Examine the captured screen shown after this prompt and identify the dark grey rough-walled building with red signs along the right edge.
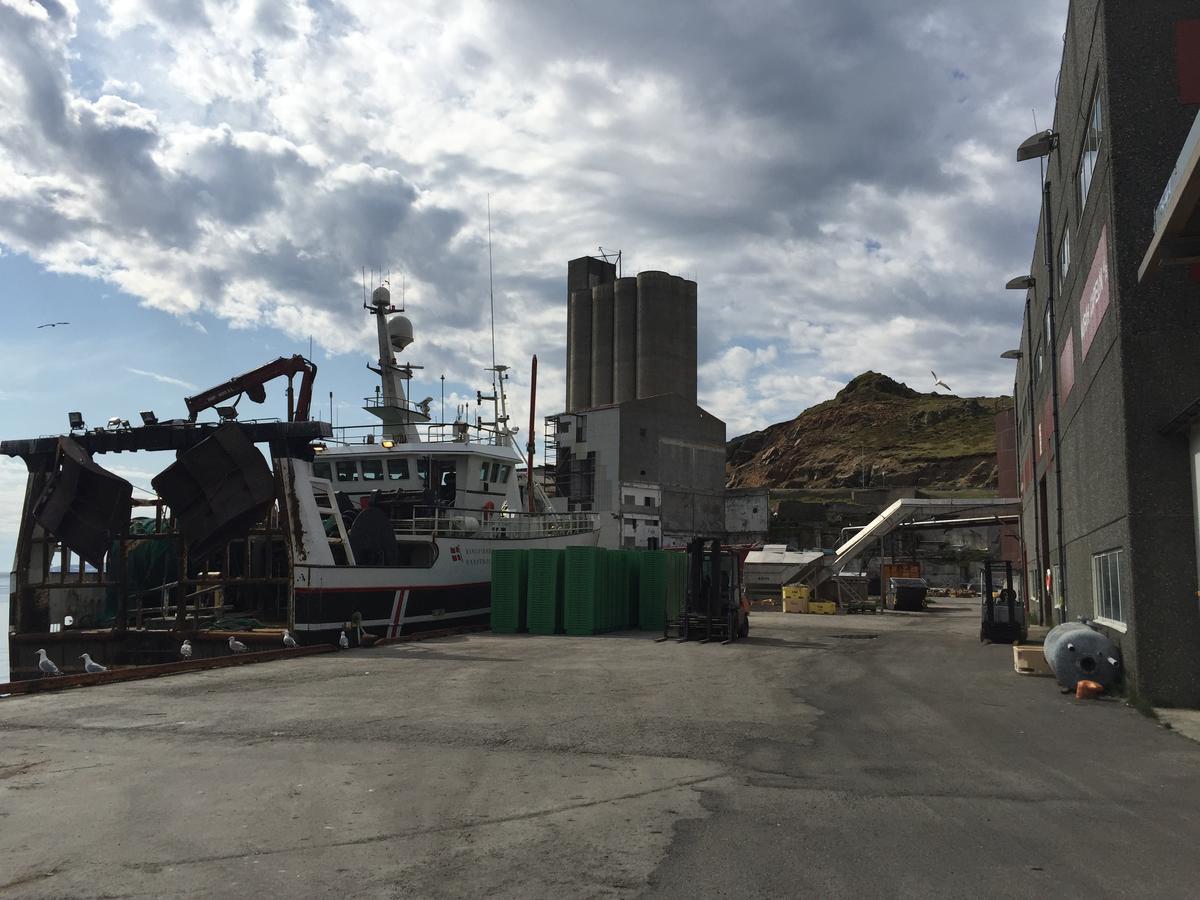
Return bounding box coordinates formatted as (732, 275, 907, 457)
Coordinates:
(1004, 0, 1200, 706)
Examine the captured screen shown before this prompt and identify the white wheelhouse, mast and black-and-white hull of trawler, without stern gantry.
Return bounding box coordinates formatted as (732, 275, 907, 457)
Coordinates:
(275, 286, 599, 640)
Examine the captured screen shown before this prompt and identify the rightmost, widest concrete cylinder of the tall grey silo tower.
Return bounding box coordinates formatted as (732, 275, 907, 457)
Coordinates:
(637, 271, 695, 398)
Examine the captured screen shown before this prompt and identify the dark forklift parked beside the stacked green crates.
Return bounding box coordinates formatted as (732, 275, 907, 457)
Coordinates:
(659, 538, 750, 644)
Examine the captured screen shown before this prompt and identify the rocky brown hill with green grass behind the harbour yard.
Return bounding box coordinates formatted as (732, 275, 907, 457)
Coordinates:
(725, 372, 1013, 490)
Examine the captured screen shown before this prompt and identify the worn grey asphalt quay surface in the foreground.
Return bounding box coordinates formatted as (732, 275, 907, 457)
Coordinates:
(0, 600, 1200, 899)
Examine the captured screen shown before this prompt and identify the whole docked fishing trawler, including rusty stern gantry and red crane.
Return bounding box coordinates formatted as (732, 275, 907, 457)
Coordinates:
(0, 284, 599, 668)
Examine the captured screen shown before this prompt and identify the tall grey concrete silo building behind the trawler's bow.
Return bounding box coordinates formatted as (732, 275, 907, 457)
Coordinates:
(545, 257, 725, 547)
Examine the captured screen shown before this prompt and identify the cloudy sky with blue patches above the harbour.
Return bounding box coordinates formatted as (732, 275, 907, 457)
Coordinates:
(0, 0, 1067, 553)
